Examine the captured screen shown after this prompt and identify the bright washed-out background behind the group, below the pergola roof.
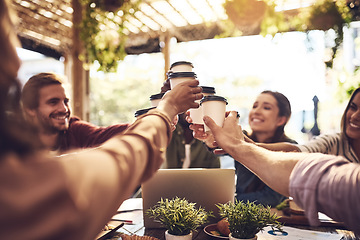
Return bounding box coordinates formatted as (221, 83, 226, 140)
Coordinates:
(12, 0, 360, 166)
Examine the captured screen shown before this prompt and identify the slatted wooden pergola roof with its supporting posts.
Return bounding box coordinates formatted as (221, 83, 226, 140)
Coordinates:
(12, 0, 315, 119)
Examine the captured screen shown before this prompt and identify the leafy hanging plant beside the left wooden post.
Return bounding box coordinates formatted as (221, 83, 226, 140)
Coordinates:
(80, 0, 140, 72)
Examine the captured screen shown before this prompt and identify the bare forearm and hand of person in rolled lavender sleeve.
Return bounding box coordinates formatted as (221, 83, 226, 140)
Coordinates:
(204, 112, 302, 196)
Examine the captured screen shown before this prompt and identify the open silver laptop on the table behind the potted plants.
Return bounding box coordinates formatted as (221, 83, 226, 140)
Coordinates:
(141, 168, 235, 228)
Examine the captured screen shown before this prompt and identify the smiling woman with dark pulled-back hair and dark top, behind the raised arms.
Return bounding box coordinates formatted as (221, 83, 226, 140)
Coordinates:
(235, 90, 296, 207)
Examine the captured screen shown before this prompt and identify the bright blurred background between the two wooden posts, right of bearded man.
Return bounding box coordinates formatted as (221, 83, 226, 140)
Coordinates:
(90, 53, 164, 126)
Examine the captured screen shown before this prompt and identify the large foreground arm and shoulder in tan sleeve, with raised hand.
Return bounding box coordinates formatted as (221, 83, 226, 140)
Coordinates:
(0, 80, 202, 239)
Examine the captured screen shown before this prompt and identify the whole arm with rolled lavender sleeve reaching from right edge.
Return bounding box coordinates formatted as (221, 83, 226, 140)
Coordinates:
(204, 112, 360, 234)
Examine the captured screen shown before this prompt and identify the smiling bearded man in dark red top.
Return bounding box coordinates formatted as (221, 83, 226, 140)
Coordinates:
(21, 73, 129, 153)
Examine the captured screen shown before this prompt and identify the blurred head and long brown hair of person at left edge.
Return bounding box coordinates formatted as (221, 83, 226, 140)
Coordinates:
(0, 0, 40, 156)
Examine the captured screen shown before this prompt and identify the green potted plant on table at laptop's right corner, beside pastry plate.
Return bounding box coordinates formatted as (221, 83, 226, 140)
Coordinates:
(217, 200, 282, 240)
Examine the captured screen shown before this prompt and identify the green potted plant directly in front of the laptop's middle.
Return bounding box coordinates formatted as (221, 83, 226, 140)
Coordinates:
(146, 197, 212, 240)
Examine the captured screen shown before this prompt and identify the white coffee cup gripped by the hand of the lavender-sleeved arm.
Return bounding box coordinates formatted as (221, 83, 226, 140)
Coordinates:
(200, 95, 228, 132)
